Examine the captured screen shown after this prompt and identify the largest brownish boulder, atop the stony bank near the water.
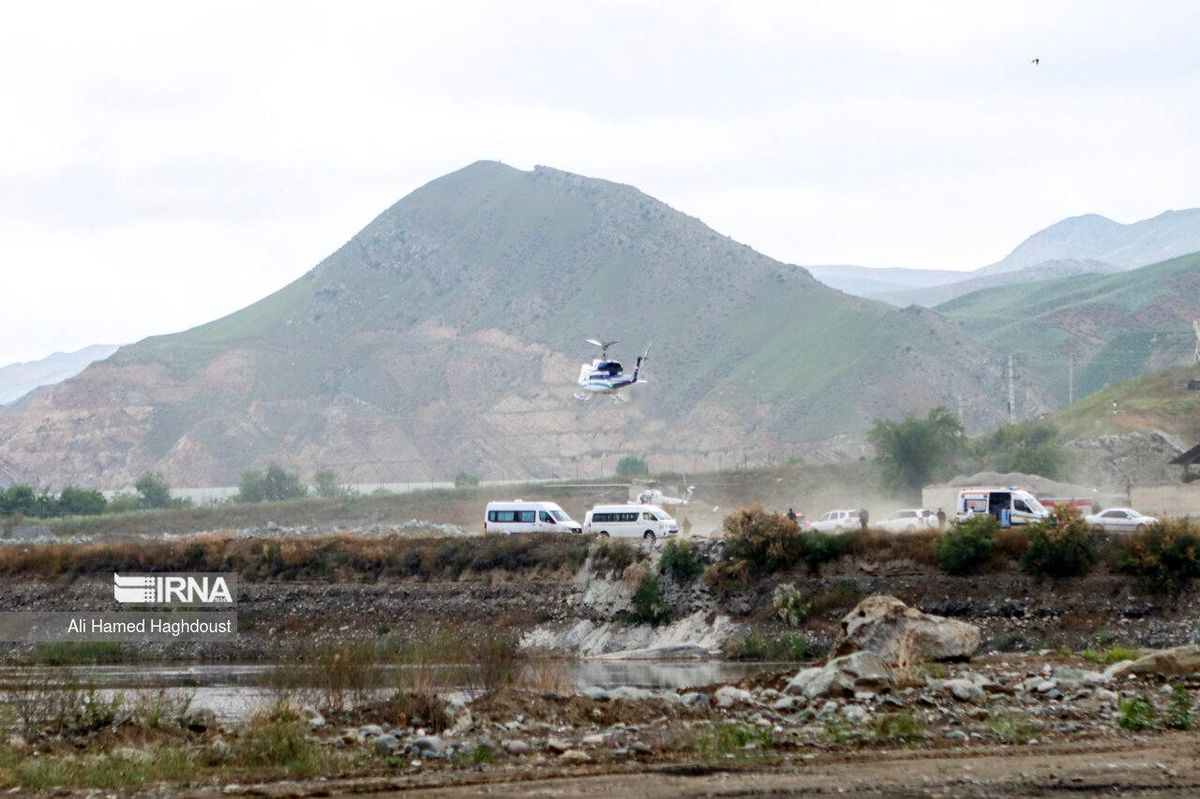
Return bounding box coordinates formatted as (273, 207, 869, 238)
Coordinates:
(836, 596, 980, 663)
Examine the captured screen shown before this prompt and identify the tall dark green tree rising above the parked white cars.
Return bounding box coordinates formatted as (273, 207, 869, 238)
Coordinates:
(866, 408, 962, 494)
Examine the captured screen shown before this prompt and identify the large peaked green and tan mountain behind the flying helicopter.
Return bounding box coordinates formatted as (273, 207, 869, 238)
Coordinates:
(0, 162, 1002, 486)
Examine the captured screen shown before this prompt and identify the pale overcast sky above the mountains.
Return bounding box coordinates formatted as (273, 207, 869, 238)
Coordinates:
(0, 0, 1200, 364)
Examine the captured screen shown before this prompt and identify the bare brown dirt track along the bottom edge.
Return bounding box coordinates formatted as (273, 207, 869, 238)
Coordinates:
(216, 734, 1200, 799)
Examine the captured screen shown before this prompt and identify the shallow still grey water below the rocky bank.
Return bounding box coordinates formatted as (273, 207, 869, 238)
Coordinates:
(0, 660, 787, 721)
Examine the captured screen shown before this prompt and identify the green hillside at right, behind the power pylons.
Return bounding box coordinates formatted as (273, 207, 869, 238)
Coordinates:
(937, 253, 1200, 405)
